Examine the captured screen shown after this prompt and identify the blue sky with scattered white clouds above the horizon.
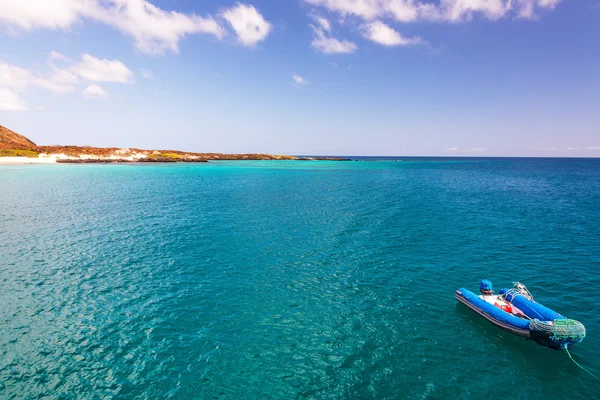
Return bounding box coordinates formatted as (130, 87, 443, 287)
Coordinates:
(0, 0, 600, 157)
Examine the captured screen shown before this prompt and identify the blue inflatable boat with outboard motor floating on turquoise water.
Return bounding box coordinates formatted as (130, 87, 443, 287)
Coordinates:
(456, 280, 585, 349)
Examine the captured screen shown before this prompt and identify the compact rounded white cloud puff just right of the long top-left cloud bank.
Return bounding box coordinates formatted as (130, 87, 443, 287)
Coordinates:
(221, 3, 272, 47)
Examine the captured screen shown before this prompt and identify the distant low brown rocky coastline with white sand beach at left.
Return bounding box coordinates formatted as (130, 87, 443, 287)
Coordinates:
(0, 125, 347, 164)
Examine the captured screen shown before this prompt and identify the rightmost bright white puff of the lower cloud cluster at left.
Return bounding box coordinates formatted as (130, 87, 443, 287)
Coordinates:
(71, 54, 133, 83)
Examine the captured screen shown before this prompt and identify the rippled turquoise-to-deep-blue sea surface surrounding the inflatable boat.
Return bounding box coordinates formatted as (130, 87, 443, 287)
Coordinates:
(0, 158, 600, 399)
